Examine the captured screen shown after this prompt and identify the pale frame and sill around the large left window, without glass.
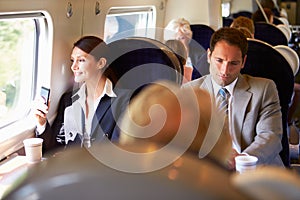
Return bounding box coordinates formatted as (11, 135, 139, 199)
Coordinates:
(0, 11, 53, 160)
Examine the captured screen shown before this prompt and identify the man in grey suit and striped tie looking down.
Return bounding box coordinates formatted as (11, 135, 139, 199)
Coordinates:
(183, 27, 283, 169)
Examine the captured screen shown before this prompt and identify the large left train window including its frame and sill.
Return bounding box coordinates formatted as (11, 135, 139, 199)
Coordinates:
(0, 12, 52, 159)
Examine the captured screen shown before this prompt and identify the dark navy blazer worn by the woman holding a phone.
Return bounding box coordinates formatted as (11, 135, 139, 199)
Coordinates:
(36, 88, 131, 152)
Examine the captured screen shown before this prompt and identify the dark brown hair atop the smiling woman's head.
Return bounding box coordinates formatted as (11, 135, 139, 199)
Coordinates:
(73, 36, 108, 60)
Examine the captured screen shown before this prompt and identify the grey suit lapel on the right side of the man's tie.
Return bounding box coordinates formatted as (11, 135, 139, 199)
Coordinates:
(231, 75, 252, 151)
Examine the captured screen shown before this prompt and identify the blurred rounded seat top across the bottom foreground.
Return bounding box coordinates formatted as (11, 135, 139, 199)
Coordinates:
(5, 143, 249, 200)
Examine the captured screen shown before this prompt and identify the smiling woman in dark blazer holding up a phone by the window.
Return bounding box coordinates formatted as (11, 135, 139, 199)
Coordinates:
(35, 36, 129, 153)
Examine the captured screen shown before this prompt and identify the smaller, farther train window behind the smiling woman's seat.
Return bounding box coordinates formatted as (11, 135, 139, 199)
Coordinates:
(104, 6, 156, 43)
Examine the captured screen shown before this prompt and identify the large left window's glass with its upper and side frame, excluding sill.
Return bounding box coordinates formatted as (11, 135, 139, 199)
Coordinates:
(0, 13, 46, 130)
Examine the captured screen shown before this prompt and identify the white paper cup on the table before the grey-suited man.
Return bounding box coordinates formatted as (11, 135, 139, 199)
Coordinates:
(235, 156, 258, 174)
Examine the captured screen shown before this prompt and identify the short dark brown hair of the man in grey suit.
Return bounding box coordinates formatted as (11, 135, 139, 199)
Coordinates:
(210, 27, 248, 59)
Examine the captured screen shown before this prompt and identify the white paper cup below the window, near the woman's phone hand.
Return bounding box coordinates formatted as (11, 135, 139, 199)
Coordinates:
(23, 138, 43, 163)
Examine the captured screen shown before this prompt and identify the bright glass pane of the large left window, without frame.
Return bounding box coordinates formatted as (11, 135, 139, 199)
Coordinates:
(0, 16, 35, 127)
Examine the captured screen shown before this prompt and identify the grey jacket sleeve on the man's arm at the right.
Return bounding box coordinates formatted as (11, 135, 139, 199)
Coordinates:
(243, 81, 283, 164)
